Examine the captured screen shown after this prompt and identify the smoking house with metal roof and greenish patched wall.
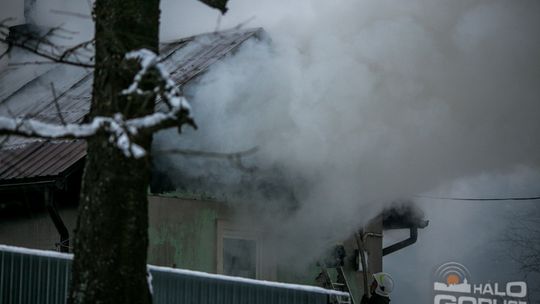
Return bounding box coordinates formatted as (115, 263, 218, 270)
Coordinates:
(0, 2, 427, 303)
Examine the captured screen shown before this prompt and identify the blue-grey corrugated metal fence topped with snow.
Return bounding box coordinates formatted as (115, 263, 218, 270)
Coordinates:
(0, 245, 346, 304)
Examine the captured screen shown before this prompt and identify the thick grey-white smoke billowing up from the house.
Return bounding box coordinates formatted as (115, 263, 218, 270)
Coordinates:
(157, 0, 540, 264)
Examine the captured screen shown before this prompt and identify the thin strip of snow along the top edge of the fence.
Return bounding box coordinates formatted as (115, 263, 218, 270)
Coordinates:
(0, 245, 349, 296)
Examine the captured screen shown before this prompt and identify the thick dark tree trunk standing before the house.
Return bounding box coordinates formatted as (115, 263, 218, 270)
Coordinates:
(69, 0, 159, 304)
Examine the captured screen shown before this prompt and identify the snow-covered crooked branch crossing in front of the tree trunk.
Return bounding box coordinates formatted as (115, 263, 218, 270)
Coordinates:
(0, 49, 196, 158)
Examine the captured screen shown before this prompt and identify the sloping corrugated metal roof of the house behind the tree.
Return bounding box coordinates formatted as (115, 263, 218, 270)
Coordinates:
(0, 29, 262, 184)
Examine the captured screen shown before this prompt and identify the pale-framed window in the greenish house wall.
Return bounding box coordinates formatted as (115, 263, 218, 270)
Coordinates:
(223, 237, 257, 279)
